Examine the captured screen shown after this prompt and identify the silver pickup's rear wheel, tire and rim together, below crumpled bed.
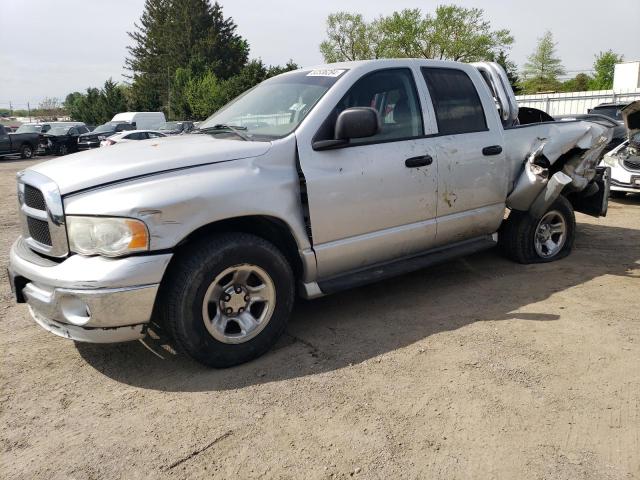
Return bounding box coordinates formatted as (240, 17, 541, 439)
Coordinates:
(498, 195, 576, 263)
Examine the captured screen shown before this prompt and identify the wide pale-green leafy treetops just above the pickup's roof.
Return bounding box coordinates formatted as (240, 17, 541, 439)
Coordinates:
(320, 5, 513, 62)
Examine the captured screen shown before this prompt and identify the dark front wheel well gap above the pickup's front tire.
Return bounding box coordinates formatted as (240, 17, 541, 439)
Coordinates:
(176, 215, 303, 278)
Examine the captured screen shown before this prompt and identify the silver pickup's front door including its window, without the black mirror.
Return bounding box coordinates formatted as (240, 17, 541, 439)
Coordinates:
(299, 68, 437, 279)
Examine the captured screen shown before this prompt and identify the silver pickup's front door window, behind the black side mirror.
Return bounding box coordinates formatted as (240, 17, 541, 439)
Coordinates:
(316, 68, 424, 144)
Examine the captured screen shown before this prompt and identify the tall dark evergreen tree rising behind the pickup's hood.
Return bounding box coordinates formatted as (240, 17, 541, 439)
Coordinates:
(125, 0, 249, 116)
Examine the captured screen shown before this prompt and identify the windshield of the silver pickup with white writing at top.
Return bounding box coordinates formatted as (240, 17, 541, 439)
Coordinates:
(198, 70, 345, 141)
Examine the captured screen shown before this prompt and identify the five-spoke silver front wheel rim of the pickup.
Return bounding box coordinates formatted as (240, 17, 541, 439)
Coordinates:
(202, 264, 276, 344)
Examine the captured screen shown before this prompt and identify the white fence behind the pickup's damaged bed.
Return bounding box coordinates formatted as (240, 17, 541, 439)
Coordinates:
(516, 88, 640, 117)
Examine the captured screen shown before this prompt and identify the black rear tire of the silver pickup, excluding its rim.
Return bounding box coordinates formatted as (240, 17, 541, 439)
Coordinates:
(498, 195, 576, 264)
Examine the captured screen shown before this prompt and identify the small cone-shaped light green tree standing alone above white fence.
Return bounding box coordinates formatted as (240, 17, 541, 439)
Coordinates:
(522, 31, 565, 93)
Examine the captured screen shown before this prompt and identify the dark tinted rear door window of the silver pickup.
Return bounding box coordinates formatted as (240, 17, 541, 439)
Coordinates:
(422, 68, 487, 135)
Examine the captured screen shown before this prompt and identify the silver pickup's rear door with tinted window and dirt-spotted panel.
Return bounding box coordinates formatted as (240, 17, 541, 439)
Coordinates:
(421, 67, 508, 245)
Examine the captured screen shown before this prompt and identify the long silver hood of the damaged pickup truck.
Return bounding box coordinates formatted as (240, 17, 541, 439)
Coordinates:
(30, 135, 271, 195)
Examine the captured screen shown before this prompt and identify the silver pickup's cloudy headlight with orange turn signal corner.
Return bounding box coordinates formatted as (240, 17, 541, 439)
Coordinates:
(66, 215, 149, 257)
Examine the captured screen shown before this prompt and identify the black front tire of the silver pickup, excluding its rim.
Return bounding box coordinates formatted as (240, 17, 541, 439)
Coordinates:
(157, 233, 295, 368)
